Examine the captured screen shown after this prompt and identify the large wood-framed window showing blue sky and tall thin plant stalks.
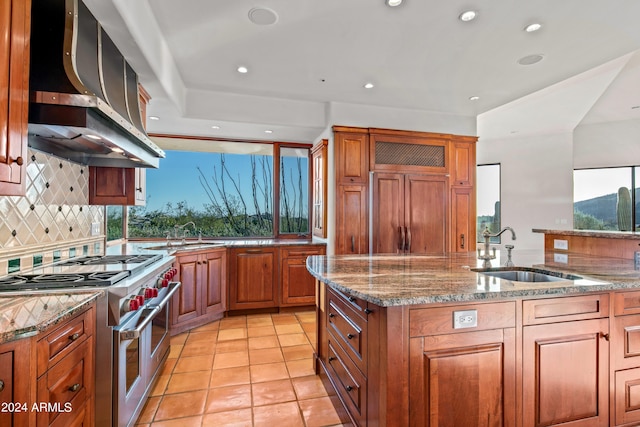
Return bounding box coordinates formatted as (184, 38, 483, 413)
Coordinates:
(128, 141, 309, 238)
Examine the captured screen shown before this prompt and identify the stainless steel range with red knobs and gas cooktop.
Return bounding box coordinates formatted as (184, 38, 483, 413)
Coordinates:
(0, 254, 180, 427)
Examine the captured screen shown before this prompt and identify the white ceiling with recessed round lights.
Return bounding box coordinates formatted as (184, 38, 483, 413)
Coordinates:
(85, 0, 640, 142)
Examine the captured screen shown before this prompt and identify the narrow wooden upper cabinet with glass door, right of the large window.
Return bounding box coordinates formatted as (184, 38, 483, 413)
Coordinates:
(311, 139, 328, 237)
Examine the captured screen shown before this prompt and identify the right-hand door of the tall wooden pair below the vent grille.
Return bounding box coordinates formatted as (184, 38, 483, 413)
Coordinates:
(404, 175, 448, 253)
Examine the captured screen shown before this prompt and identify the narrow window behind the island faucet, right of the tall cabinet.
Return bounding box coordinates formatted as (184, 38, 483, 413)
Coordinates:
(476, 164, 501, 243)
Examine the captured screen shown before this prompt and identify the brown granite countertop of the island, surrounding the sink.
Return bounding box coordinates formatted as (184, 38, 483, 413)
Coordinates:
(307, 251, 640, 307)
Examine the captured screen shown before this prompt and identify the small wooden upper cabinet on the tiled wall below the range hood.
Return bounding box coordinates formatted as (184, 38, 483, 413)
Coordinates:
(89, 166, 146, 205)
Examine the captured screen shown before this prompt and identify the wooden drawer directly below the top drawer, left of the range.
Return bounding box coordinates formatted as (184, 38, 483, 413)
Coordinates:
(37, 336, 94, 425)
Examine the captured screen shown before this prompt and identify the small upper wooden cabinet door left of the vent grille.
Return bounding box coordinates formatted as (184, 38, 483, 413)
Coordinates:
(333, 126, 369, 184)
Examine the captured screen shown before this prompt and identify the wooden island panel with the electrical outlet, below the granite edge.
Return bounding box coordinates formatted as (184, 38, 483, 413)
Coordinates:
(409, 301, 516, 337)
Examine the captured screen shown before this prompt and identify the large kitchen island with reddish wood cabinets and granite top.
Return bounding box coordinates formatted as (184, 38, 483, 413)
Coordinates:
(307, 251, 640, 427)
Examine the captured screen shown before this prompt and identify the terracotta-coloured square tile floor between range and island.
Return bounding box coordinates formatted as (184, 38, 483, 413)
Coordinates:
(137, 311, 351, 427)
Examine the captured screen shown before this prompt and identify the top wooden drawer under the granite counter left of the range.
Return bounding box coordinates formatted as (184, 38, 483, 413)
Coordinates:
(37, 308, 95, 376)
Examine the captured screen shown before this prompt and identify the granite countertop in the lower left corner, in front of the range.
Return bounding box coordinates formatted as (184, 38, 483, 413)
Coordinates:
(0, 291, 103, 344)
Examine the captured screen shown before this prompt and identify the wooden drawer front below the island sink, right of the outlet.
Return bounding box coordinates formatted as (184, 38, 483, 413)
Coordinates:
(522, 294, 609, 325)
